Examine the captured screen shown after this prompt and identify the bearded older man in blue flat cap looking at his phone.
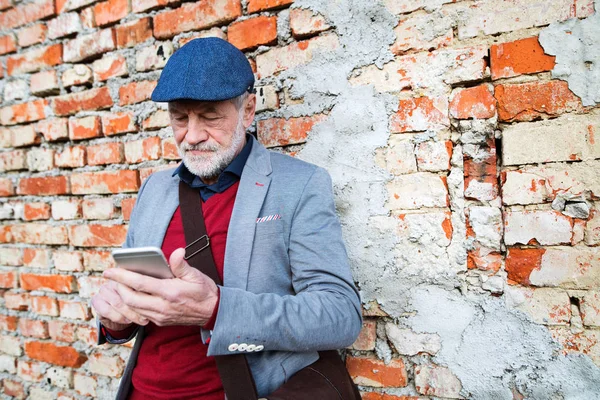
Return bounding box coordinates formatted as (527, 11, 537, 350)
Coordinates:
(92, 38, 361, 400)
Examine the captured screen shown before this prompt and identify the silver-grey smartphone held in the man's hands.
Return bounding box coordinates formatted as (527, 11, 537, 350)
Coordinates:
(112, 247, 174, 279)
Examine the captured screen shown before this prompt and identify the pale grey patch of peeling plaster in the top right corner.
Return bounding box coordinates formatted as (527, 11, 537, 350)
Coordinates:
(539, 0, 600, 106)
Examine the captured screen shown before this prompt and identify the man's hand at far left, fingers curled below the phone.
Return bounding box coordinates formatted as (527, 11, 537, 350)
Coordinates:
(92, 281, 148, 331)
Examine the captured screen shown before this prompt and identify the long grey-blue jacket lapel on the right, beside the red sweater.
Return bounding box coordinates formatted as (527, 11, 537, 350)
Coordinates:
(223, 138, 272, 290)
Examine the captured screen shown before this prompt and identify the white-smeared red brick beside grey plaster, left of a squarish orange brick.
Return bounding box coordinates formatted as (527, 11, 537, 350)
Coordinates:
(391, 96, 450, 133)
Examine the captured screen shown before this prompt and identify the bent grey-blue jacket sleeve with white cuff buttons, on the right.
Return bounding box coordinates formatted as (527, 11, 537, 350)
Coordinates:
(208, 168, 362, 356)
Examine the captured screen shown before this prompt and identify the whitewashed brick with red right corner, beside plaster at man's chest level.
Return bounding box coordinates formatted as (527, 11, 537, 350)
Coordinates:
(387, 172, 449, 210)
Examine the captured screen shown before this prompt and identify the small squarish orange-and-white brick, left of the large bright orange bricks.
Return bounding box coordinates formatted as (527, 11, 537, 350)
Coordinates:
(450, 85, 496, 119)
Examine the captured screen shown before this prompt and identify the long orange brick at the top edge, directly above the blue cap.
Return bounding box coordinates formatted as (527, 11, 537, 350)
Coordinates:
(154, 0, 242, 39)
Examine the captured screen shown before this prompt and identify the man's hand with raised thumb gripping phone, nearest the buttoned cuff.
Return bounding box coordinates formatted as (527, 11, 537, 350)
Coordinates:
(103, 248, 218, 326)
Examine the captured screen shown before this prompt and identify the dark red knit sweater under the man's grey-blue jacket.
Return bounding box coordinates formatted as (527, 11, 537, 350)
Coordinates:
(129, 182, 239, 400)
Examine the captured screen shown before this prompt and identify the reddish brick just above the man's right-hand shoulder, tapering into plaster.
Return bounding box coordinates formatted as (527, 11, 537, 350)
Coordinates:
(257, 114, 326, 147)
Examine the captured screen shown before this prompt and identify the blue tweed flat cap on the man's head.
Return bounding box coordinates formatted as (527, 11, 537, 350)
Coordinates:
(152, 37, 254, 102)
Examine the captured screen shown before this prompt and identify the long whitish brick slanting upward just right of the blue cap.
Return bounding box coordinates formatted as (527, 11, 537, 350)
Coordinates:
(256, 34, 340, 78)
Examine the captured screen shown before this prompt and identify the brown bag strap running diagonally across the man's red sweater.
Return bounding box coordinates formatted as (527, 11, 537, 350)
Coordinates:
(179, 182, 258, 400)
